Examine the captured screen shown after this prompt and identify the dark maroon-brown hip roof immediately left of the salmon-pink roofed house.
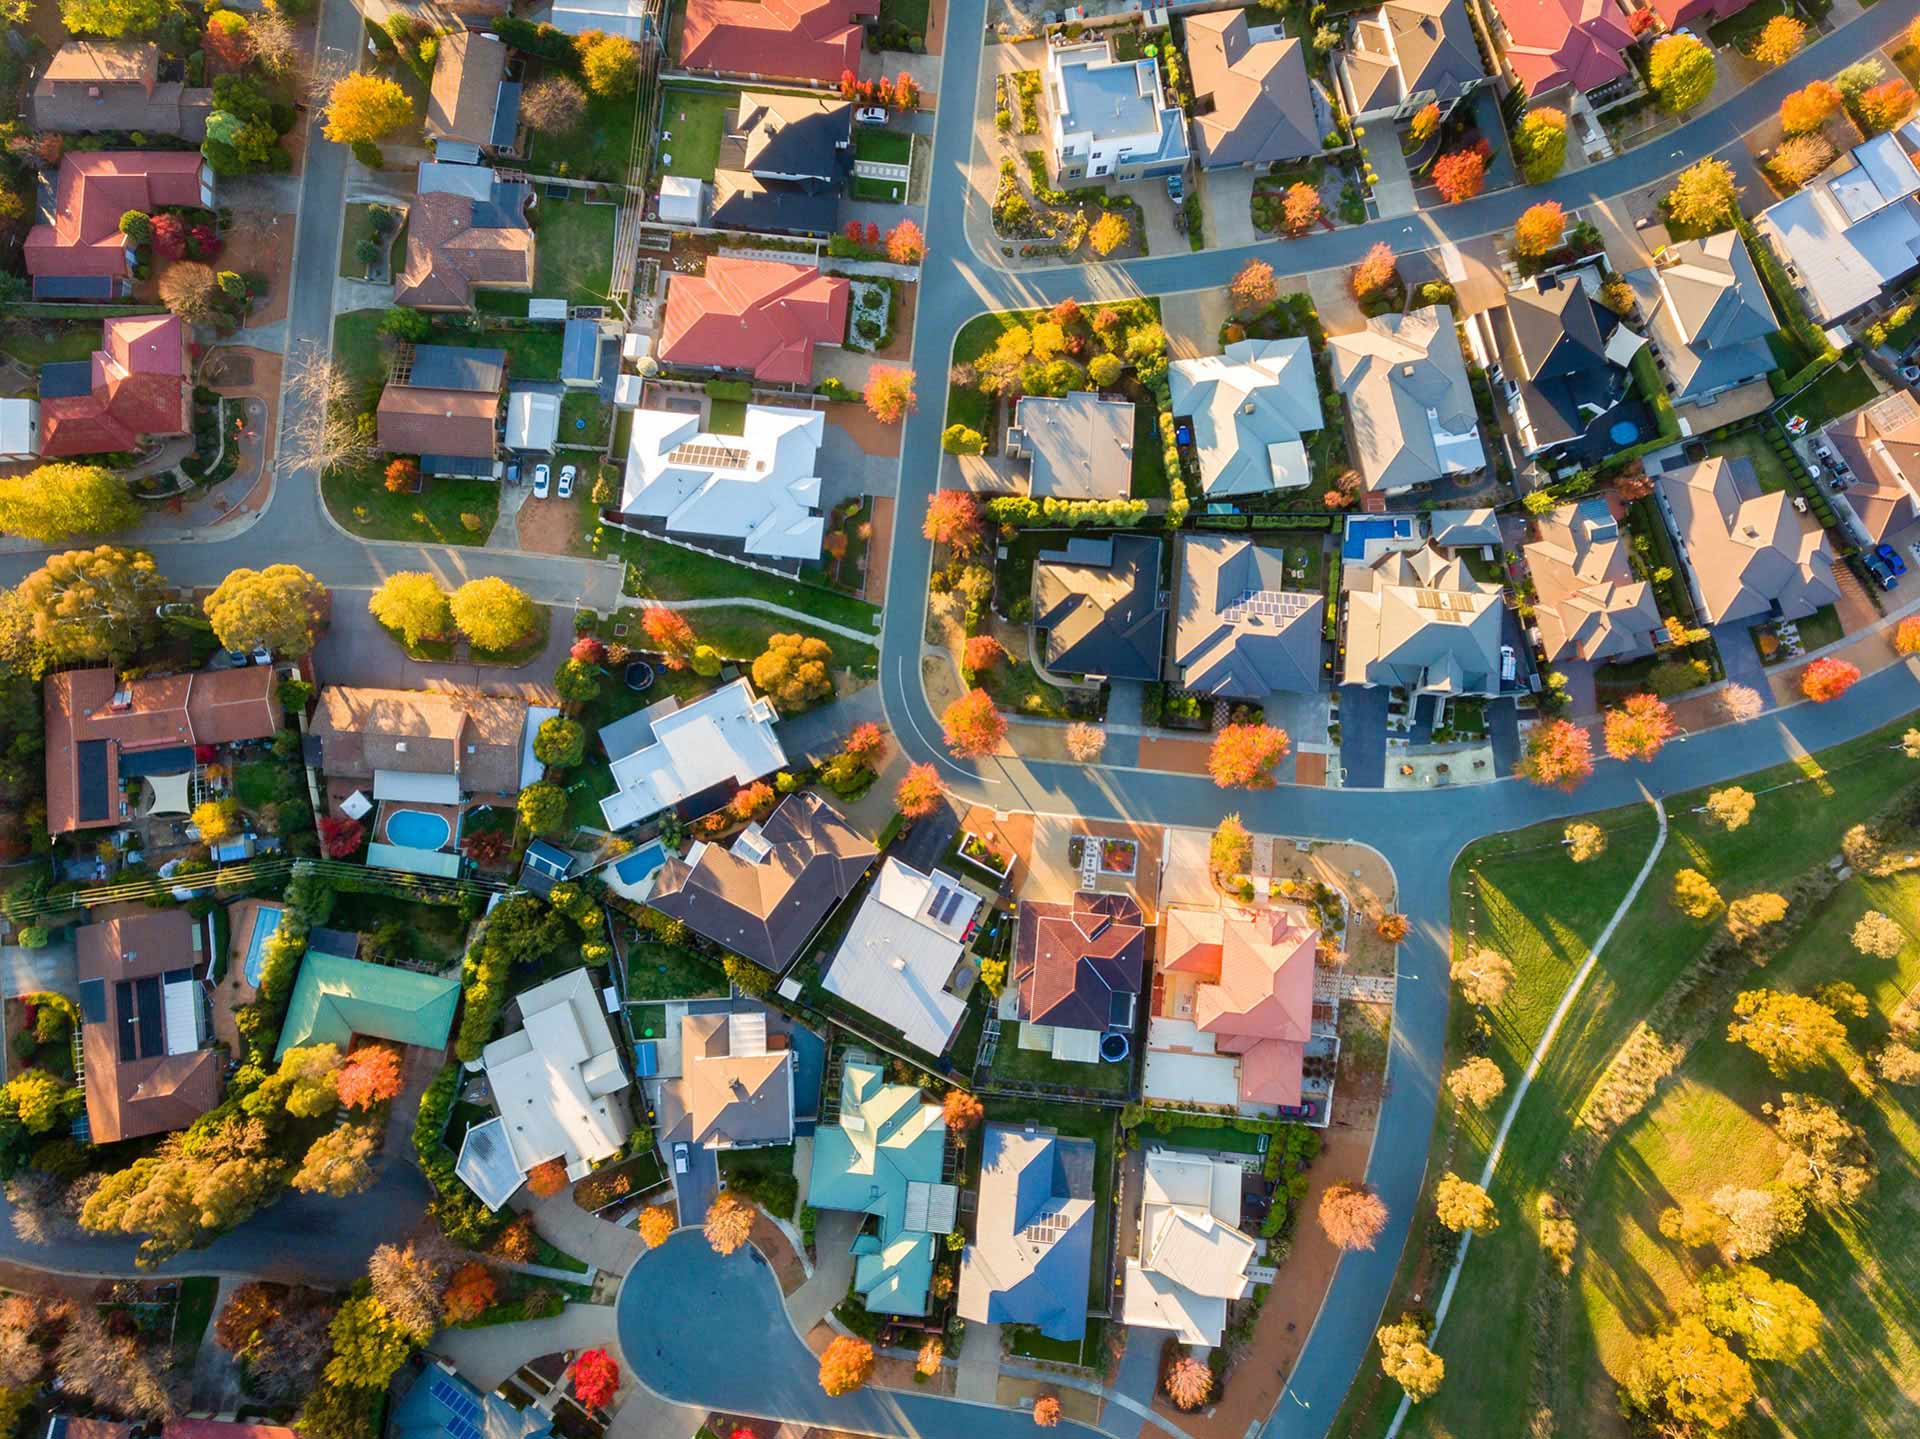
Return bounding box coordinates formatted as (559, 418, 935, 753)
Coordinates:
(1014, 890, 1146, 1030)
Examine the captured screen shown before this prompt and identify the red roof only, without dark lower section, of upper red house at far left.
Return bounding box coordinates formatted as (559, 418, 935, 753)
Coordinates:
(25, 150, 211, 275)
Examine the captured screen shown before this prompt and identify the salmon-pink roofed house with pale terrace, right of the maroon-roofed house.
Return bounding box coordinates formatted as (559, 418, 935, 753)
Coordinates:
(1146, 905, 1319, 1109)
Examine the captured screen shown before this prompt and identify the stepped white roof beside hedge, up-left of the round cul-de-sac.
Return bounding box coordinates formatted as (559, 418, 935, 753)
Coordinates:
(480, 968, 632, 1178)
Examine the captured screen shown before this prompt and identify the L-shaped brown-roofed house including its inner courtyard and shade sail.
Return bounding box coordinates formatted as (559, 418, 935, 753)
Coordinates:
(44, 665, 282, 834)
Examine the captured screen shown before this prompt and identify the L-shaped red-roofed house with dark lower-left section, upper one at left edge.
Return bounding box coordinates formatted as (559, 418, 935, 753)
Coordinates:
(23, 150, 213, 300)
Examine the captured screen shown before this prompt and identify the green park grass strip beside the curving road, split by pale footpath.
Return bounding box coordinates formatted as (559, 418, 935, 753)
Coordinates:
(1331, 720, 1920, 1439)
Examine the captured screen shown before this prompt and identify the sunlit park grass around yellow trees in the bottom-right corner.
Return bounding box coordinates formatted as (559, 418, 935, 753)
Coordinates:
(1555, 874, 1920, 1439)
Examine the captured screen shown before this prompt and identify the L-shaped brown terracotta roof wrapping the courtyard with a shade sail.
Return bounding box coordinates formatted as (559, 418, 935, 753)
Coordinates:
(44, 665, 282, 834)
